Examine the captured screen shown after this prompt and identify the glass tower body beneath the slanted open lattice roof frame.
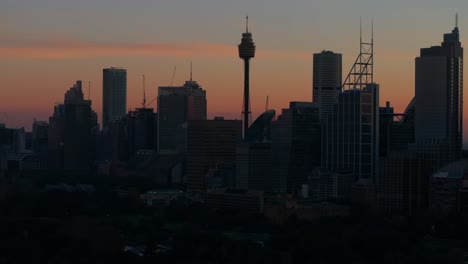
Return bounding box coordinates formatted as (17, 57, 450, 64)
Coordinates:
(322, 84, 379, 181)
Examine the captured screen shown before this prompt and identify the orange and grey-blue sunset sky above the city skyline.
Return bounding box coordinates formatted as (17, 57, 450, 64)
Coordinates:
(0, 0, 468, 138)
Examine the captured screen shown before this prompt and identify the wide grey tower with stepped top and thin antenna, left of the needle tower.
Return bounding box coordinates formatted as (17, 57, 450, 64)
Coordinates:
(158, 80, 207, 153)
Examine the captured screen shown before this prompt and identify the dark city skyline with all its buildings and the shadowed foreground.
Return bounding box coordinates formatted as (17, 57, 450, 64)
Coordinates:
(0, 13, 468, 263)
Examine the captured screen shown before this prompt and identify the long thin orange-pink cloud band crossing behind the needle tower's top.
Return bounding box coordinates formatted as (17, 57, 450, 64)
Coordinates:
(0, 36, 310, 59)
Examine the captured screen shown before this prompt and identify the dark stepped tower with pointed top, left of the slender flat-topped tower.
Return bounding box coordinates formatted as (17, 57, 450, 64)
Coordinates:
(49, 81, 97, 171)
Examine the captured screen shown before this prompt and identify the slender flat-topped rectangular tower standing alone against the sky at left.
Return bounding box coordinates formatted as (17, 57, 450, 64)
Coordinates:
(102, 67, 127, 129)
